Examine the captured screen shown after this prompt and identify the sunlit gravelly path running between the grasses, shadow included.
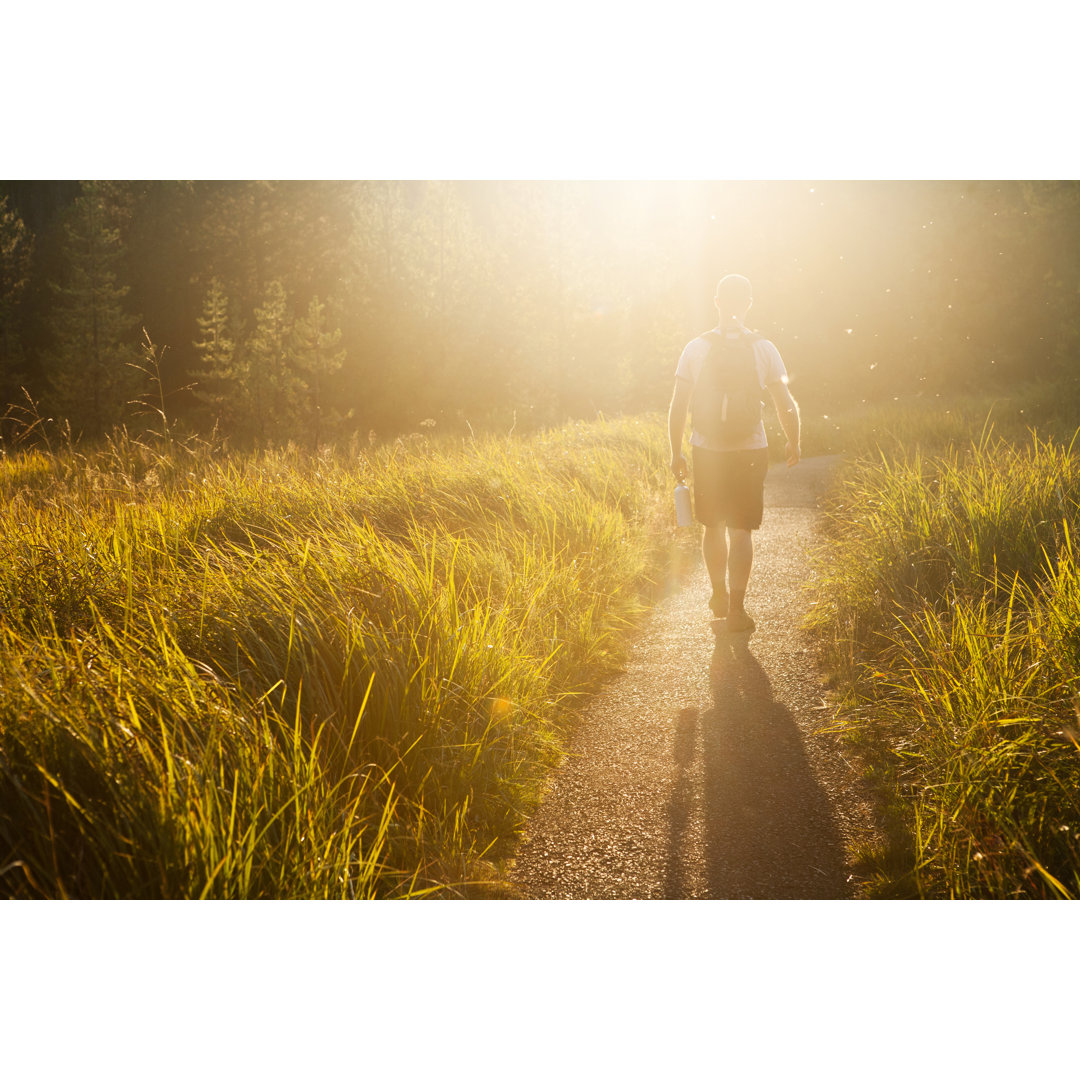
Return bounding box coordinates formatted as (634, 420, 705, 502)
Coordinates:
(511, 458, 874, 900)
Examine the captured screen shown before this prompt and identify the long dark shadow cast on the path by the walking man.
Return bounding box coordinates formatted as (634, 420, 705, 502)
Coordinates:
(664, 635, 851, 900)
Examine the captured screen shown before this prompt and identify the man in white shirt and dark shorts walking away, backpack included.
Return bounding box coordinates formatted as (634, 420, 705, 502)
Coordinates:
(667, 274, 799, 632)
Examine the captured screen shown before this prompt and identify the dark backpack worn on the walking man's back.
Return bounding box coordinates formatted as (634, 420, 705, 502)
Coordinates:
(691, 330, 761, 443)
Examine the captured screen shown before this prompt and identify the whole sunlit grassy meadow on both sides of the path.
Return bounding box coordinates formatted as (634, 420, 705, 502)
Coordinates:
(8, 375, 1080, 899)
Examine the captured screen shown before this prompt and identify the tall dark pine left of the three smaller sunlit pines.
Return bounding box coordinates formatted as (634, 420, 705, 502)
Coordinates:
(48, 181, 139, 435)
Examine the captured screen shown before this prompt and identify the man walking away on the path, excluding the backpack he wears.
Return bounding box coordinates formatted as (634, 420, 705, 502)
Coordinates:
(667, 274, 799, 632)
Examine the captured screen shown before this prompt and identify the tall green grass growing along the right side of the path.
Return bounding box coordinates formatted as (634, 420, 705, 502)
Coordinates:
(811, 418, 1080, 897)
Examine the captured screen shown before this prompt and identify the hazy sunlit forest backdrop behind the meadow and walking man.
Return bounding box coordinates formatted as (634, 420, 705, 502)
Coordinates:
(0, 180, 1080, 446)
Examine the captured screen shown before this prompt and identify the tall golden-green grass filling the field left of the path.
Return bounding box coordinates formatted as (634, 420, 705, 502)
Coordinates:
(0, 419, 666, 897)
